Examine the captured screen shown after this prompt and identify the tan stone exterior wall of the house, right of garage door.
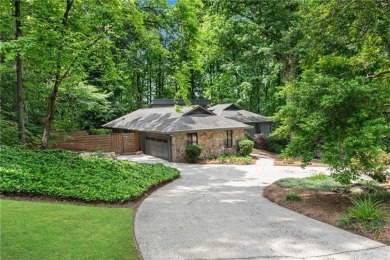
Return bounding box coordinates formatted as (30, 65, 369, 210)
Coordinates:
(172, 129, 244, 162)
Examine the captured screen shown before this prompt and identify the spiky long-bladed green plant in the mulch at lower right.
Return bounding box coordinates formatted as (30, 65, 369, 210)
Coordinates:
(340, 196, 386, 230)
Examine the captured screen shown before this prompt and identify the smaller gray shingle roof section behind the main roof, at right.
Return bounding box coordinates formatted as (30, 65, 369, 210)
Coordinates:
(209, 104, 272, 123)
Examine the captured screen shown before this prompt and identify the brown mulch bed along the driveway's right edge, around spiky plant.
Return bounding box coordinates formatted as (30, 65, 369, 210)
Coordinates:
(263, 184, 390, 245)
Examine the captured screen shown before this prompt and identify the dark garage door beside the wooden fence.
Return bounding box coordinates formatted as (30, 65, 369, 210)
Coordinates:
(143, 134, 170, 161)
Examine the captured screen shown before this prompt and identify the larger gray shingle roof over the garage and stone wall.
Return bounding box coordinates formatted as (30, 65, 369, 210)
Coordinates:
(103, 106, 252, 134)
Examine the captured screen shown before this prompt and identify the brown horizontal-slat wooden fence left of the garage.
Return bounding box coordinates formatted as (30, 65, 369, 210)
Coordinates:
(56, 131, 140, 154)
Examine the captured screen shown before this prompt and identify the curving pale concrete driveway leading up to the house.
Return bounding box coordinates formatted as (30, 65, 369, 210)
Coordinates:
(122, 156, 390, 260)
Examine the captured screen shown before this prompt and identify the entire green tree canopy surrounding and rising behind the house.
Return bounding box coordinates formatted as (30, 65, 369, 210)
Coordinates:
(0, 0, 390, 179)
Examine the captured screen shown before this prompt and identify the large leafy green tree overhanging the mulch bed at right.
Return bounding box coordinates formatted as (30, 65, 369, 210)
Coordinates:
(276, 0, 390, 182)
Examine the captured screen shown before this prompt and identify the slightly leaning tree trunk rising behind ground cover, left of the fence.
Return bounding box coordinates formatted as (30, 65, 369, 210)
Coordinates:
(41, 0, 74, 149)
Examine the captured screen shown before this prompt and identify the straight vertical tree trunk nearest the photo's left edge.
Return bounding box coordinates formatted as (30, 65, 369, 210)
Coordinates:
(14, 0, 26, 144)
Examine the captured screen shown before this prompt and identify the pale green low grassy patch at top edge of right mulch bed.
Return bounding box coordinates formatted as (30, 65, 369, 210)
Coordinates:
(275, 174, 344, 191)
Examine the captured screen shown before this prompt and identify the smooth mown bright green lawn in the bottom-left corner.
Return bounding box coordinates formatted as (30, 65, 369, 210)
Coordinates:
(0, 199, 139, 260)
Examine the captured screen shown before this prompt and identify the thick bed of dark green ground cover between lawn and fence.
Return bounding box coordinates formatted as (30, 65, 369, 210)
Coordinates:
(0, 146, 180, 202)
